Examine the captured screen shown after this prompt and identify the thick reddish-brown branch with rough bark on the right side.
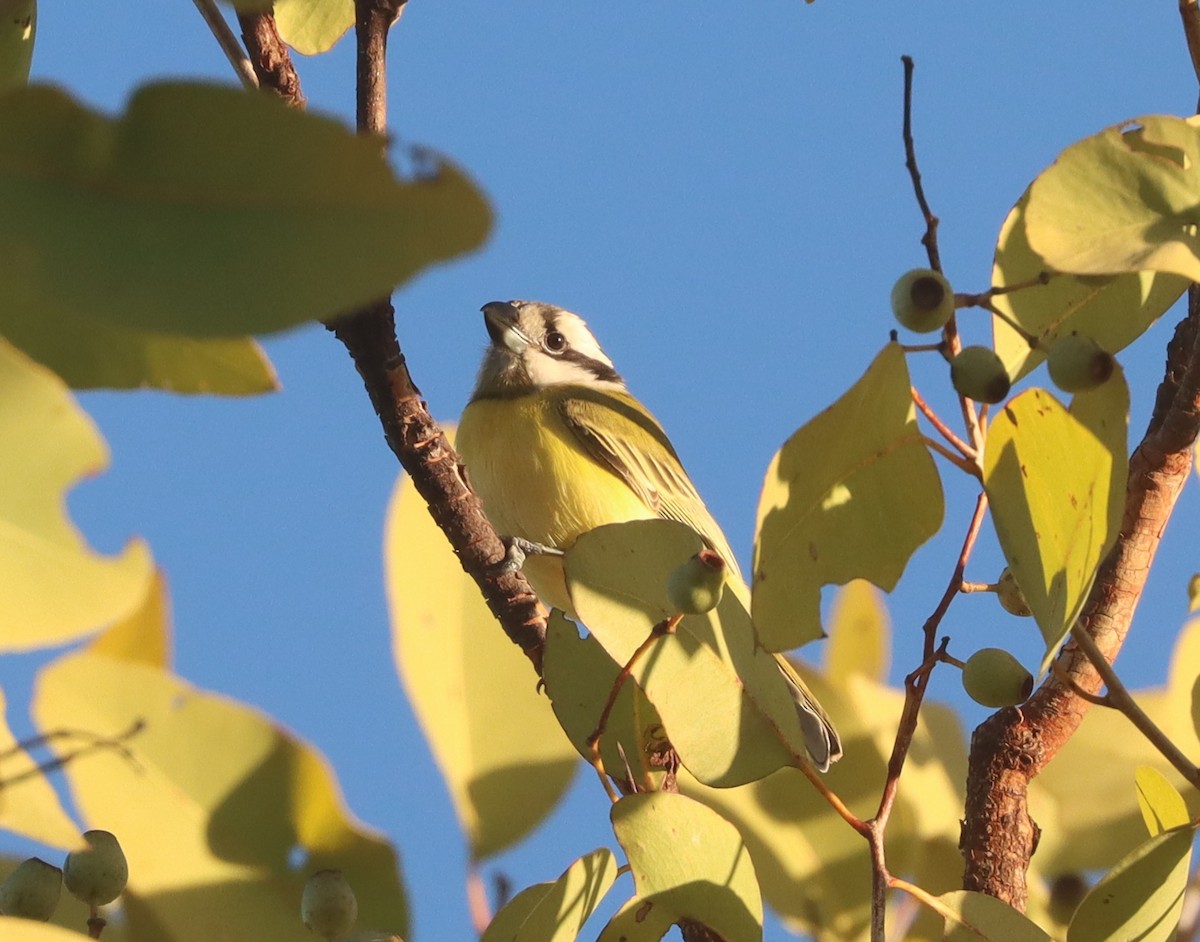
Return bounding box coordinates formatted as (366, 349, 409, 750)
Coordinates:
(960, 286, 1200, 910)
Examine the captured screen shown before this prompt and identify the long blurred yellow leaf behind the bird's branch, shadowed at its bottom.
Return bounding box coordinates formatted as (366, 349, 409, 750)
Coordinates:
(384, 458, 578, 859)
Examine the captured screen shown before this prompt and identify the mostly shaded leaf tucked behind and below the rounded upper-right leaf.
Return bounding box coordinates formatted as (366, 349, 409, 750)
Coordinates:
(991, 193, 1189, 382)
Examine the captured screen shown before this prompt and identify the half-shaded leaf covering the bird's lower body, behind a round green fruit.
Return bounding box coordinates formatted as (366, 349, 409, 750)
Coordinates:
(564, 520, 805, 786)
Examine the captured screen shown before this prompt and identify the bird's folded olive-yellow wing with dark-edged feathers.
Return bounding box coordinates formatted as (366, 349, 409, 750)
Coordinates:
(558, 386, 742, 580)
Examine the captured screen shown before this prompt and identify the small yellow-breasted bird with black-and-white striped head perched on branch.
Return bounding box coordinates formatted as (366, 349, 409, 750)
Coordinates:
(455, 301, 842, 772)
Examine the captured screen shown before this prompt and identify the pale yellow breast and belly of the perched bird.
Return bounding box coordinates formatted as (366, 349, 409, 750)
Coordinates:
(456, 391, 656, 611)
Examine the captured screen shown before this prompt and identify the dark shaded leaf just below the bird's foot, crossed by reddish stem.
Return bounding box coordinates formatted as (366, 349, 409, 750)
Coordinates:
(542, 608, 666, 791)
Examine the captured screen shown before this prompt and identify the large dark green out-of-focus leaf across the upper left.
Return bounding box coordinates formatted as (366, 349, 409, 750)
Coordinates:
(0, 84, 490, 336)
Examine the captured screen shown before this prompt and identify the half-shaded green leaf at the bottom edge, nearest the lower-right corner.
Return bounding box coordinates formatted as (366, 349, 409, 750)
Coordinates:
(1067, 827, 1194, 942)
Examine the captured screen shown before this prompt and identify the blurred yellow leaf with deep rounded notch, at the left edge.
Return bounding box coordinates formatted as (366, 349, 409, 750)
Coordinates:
(0, 340, 152, 652)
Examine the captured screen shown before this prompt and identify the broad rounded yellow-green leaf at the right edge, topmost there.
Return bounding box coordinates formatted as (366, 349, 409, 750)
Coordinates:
(1026, 115, 1200, 281)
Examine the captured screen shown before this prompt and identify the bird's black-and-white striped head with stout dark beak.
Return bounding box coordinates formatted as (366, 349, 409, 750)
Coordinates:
(475, 301, 624, 397)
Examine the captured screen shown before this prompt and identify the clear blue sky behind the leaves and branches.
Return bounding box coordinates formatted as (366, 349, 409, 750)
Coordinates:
(11, 0, 1200, 940)
